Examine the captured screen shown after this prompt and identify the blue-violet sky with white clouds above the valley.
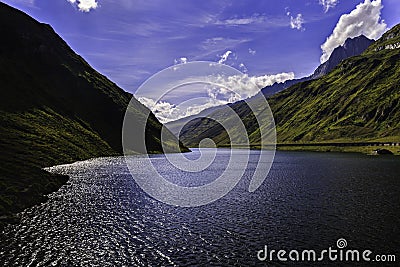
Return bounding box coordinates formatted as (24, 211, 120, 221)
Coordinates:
(3, 0, 400, 122)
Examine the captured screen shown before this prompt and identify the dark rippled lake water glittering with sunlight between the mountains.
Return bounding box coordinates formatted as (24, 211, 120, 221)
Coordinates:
(0, 150, 400, 266)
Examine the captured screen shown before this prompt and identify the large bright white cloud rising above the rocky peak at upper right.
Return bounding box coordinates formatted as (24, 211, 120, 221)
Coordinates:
(321, 0, 387, 63)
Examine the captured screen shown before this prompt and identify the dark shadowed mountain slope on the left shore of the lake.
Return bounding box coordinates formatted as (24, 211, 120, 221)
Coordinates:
(0, 3, 184, 221)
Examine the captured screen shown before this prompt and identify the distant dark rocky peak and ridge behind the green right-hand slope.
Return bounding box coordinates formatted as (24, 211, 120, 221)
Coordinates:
(261, 35, 374, 96)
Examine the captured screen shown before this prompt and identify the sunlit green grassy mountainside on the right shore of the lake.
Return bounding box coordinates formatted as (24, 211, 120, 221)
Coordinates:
(180, 24, 400, 147)
